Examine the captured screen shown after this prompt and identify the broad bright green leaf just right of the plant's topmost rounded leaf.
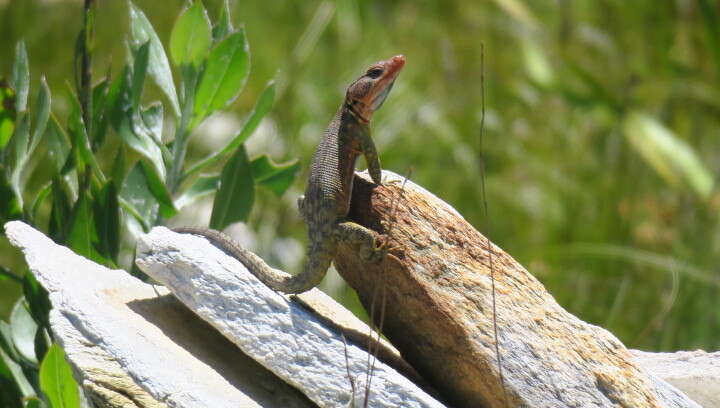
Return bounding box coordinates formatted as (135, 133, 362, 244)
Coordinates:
(190, 29, 250, 129)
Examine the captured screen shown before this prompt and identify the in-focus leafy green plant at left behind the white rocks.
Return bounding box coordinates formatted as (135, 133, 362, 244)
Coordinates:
(0, 0, 298, 407)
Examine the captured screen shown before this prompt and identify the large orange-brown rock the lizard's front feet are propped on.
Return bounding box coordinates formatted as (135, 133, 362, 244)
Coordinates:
(335, 172, 698, 408)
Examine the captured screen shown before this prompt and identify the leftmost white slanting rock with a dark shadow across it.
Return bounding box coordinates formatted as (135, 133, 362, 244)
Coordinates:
(5, 221, 313, 408)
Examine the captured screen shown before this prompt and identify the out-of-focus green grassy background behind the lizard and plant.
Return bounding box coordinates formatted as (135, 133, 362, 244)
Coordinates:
(0, 0, 720, 350)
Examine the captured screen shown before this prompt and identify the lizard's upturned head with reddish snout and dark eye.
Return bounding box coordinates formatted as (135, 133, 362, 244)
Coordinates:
(345, 55, 405, 122)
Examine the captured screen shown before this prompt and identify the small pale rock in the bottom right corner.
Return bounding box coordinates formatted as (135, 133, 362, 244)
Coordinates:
(630, 350, 720, 408)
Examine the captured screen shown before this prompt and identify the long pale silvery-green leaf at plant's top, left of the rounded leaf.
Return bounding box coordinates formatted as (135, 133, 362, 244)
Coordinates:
(128, 1, 180, 117)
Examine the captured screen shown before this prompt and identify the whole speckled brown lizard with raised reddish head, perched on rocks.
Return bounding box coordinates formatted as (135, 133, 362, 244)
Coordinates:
(173, 55, 405, 294)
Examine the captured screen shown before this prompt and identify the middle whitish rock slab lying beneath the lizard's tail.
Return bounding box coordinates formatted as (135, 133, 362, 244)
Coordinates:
(136, 227, 443, 407)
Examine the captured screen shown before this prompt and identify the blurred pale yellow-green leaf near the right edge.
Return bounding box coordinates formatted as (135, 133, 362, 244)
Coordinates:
(623, 111, 713, 199)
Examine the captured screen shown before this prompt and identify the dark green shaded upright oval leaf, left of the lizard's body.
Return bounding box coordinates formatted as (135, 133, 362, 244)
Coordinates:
(210, 145, 255, 230)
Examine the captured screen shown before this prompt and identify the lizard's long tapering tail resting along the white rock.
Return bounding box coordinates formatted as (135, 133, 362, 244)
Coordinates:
(172, 227, 334, 293)
